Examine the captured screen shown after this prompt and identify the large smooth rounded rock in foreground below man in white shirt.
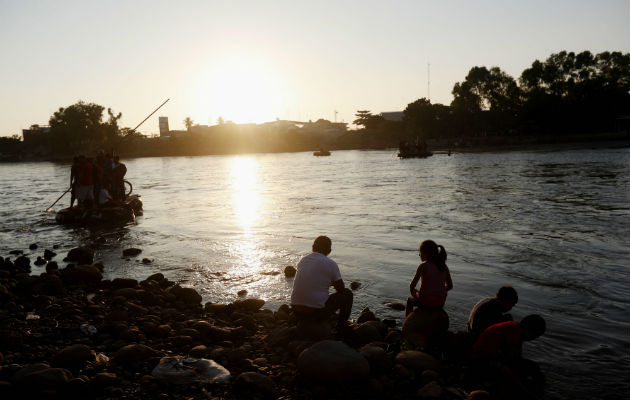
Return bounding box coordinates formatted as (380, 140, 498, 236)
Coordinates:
(297, 340, 370, 384)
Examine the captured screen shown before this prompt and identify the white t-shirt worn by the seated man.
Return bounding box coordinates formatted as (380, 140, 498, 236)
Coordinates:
(291, 252, 341, 308)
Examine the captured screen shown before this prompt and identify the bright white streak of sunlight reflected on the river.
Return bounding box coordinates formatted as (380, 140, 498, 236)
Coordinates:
(230, 157, 260, 230)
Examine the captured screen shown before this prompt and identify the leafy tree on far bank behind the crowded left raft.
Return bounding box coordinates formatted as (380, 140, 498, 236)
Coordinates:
(49, 100, 122, 153)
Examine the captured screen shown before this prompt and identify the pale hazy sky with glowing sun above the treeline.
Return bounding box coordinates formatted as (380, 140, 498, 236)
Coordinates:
(0, 0, 630, 136)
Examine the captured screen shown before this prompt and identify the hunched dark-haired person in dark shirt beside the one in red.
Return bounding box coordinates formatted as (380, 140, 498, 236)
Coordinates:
(466, 286, 518, 342)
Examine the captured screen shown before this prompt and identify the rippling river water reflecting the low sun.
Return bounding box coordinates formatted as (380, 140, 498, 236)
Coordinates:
(0, 148, 630, 399)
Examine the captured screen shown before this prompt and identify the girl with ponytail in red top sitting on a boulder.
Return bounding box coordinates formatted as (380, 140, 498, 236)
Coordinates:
(405, 240, 453, 315)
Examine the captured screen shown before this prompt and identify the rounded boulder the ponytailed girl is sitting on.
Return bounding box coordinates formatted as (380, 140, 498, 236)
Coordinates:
(402, 308, 449, 348)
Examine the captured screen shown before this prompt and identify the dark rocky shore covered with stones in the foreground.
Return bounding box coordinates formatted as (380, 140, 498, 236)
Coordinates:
(0, 247, 504, 399)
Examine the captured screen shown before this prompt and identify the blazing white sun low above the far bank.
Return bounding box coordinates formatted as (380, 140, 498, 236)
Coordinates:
(185, 55, 287, 123)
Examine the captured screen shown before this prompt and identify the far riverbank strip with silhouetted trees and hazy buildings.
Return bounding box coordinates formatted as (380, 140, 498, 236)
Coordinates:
(0, 51, 630, 161)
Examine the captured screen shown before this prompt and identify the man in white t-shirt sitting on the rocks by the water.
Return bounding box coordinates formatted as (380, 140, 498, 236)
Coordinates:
(291, 236, 353, 330)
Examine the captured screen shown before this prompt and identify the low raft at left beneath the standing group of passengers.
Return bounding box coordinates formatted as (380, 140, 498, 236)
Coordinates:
(55, 194, 142, 225)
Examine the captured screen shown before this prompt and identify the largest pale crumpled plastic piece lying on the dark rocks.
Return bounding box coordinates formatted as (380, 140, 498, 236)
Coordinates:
(151, 356, 231, 384)
